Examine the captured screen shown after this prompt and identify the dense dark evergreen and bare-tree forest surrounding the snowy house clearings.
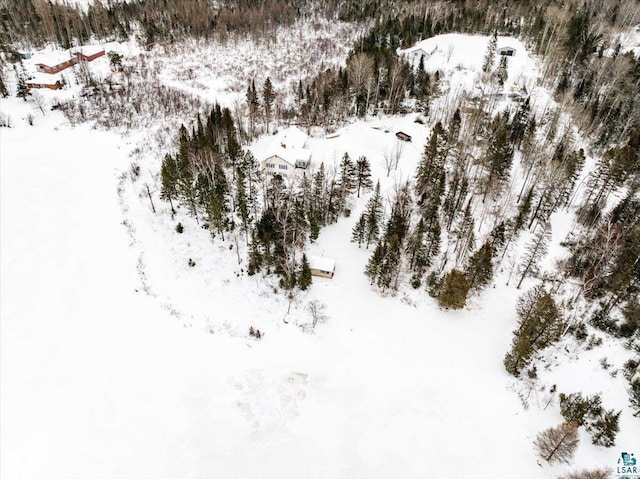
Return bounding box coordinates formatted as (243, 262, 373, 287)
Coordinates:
(0, 0, 640, 432)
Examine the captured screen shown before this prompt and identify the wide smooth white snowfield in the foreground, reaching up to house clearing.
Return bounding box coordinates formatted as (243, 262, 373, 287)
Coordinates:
(0, 31, 640, 479)
